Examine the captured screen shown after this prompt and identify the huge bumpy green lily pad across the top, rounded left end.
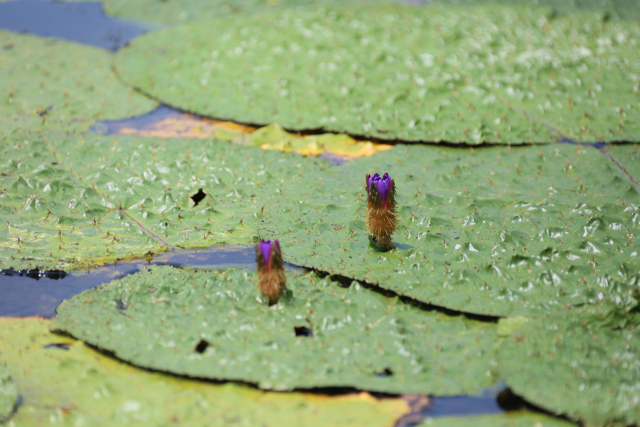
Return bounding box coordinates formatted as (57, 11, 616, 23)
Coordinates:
(115, 5, 640, 144)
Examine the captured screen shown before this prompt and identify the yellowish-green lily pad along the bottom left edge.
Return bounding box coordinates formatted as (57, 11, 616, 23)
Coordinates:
(0, 319, 407, 427)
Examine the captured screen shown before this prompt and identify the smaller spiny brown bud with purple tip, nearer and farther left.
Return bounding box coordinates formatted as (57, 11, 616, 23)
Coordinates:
(256, 240, 286, 306)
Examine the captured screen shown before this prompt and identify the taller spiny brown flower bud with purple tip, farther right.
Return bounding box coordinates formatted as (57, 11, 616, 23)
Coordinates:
(367, 173, 398, 249)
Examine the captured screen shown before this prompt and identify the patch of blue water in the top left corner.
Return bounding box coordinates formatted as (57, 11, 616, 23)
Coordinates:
(0, 0, 150, 52)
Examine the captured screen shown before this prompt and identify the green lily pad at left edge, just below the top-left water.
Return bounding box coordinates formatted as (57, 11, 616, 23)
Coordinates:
(0, 31, 158, 125)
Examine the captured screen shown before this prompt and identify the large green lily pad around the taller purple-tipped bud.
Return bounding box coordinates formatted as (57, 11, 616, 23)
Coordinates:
(260, 144, 640, 316)
